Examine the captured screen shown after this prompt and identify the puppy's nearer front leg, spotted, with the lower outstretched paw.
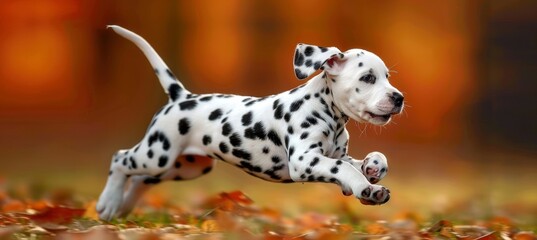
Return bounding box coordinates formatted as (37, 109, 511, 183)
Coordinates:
(289, 149, 390, 204)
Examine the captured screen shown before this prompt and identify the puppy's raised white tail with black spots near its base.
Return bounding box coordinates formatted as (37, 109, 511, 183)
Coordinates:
(107, 25, 189, 101)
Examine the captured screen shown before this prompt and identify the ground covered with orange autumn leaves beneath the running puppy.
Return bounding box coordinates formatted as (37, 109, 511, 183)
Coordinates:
(0, 187, 537, 239)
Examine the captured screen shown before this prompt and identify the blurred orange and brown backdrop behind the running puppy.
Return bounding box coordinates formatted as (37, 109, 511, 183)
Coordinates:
(0, 0, 537, 223)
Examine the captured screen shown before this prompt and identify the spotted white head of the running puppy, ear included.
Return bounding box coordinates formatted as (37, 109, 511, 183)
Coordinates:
(294, 44, 404, 125)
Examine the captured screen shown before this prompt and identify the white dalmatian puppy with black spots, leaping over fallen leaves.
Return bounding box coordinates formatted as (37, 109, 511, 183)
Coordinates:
(96, 26, 404, 220)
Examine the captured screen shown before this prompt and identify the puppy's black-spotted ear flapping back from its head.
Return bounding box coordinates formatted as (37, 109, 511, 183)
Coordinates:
(293, 43, 344, 80)
